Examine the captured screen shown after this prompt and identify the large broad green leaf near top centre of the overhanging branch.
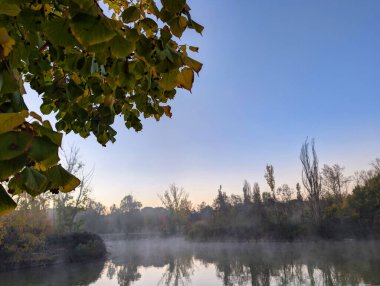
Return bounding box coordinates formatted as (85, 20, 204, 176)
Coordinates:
(70, 13, 116, 46)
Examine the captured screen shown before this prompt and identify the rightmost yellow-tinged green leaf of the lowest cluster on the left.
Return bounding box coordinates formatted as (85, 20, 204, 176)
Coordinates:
(45, 165, 80, 193)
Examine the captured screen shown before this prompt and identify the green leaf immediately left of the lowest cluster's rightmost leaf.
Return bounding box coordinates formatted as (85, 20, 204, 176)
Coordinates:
(20, 167, 49, 197)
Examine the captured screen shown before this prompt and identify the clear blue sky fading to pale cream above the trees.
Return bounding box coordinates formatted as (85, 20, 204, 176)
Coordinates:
(28, 0, 380, 206)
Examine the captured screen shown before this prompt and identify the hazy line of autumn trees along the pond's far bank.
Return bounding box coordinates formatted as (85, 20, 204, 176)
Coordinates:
(80, 140, 380, 241)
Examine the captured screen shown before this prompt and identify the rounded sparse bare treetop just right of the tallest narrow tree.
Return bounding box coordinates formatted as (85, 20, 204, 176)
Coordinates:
(322, 164, 351, 202)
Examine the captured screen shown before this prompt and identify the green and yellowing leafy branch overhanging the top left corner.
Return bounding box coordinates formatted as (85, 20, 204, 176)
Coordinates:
(0, 0, 203, 213)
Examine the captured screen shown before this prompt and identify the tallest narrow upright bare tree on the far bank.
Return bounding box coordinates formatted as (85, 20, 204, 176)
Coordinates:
(300, 139, 322, 223)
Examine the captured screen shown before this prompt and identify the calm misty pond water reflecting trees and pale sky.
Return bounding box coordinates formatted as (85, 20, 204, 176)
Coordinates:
(0, 239, 380, 286)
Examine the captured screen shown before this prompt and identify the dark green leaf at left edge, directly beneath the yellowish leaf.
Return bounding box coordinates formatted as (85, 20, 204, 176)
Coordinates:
(0, 131, 32, 160)
